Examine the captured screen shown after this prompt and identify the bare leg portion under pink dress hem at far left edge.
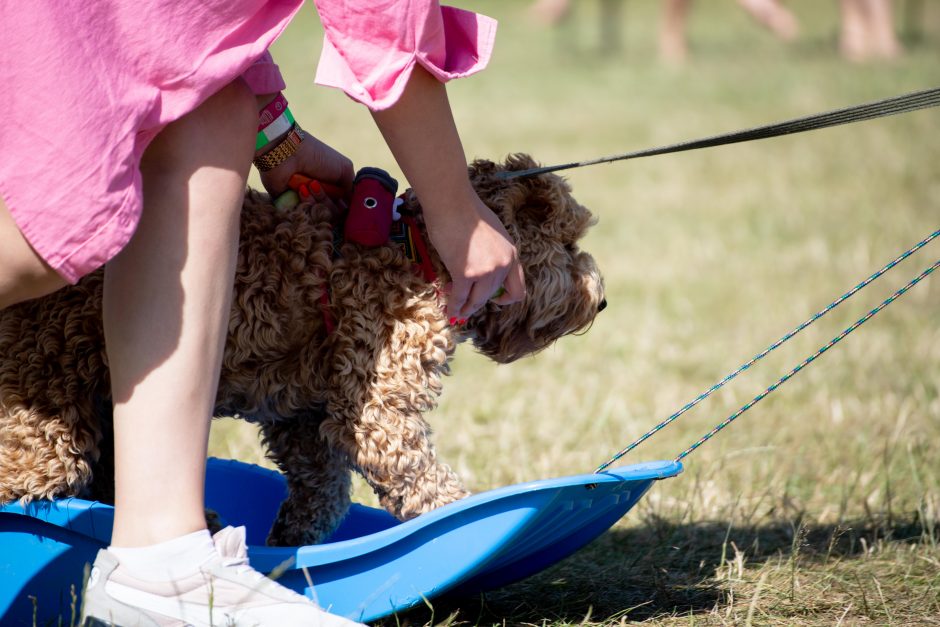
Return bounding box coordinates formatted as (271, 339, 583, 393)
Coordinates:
(0, 198, 66, 309)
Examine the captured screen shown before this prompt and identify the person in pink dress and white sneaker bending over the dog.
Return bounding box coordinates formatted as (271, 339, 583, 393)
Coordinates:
(0, 0, 525, 625)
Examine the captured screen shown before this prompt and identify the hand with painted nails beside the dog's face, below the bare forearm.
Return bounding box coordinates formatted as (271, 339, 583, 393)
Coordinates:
(424, 188, 525, 321)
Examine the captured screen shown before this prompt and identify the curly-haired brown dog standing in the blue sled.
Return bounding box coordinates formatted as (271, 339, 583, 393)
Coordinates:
(0, 155, 605, 545)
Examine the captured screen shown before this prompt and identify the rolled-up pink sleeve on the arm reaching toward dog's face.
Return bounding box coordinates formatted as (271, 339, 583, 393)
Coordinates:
(316, 0, 496, 110)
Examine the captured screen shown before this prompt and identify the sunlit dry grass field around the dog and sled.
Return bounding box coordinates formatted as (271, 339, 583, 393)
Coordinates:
(211, 0, 940, 626)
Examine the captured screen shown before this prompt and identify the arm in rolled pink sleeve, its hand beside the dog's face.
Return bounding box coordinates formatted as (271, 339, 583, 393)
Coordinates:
(316, 0, 525, 319)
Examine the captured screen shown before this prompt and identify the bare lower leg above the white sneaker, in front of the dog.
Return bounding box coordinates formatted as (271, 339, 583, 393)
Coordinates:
(104, 82, 257, 546)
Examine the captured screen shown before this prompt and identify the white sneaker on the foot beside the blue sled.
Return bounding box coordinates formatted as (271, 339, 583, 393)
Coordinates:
(81, 527, 361, 627)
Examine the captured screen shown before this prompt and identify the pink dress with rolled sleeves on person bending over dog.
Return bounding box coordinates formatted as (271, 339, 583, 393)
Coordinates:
(0, 0, 495, 282)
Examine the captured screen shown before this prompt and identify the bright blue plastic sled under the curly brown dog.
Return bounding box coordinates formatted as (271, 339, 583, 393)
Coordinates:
(0, 459, 682, 625)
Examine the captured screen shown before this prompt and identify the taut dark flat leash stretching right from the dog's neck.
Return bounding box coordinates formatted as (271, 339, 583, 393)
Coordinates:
(500, 87, 940, 179)
